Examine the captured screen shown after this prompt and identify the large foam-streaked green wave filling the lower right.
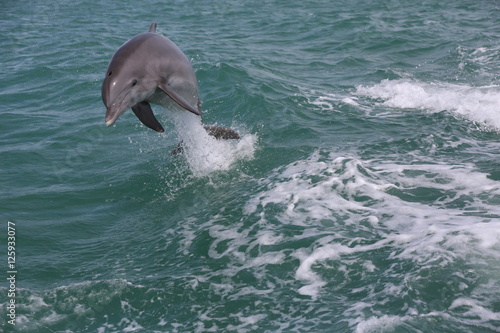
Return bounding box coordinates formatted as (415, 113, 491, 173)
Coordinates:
(246, 151, 500, 332)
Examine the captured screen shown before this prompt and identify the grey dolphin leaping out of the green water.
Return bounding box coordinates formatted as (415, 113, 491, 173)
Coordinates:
(101, 22, 239, 139)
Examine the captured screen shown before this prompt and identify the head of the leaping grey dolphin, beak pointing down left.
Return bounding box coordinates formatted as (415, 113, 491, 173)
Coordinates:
(101, 34, 157, 126)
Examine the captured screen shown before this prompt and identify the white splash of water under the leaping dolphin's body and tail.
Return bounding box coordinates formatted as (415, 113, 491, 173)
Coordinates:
(172, 110, 257, 176)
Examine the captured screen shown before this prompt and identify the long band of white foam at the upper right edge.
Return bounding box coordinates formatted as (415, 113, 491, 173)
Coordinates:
(357, 79, 500, 130)
